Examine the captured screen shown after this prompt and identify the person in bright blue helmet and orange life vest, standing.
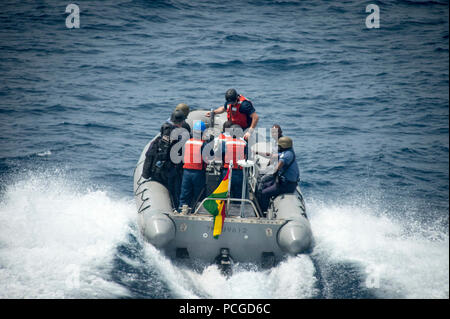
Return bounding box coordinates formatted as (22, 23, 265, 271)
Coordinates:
(179, 121, 206, 209)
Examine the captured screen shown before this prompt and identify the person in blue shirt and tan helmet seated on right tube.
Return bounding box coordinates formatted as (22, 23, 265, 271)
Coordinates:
(259, 136, 300, 212)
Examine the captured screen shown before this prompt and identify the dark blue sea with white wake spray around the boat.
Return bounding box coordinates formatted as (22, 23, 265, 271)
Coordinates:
(0, 0, 449, 299)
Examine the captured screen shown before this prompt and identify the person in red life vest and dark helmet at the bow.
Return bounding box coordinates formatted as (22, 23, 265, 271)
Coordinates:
(206, 89, 259, 140)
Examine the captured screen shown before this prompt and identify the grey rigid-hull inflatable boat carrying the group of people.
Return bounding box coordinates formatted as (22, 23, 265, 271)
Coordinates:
(134, 110, 313, 267)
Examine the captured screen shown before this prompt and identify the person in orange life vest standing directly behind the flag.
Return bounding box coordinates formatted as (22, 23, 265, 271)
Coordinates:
(222, 121, 247, 198)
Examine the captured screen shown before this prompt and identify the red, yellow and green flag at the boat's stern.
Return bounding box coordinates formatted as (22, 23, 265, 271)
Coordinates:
(203, 169, 231, 239)
